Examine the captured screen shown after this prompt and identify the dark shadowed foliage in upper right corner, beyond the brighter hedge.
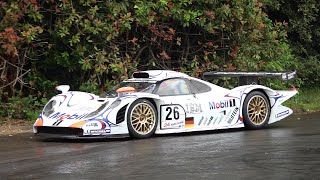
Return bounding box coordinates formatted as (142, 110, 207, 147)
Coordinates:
(268, 0, 320, 87)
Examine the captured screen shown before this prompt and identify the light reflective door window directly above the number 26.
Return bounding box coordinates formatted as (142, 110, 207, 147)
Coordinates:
(156, 79, 190, 96)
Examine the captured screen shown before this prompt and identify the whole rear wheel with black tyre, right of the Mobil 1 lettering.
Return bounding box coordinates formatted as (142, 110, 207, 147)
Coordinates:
(242, 91, 270, 129)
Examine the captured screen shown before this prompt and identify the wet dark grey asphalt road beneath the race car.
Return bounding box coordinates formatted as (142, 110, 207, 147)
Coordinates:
(0, 113, 320, 180)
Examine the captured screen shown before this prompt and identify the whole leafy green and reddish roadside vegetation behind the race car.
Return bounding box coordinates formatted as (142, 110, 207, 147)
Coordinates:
(0, 0, 320, 124)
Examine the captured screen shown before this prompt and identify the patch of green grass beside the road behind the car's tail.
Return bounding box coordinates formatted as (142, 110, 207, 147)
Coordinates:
(283, 87, 320, 112)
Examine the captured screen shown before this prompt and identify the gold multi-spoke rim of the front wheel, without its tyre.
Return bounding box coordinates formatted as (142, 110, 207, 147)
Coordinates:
(131, 103, 156, 134)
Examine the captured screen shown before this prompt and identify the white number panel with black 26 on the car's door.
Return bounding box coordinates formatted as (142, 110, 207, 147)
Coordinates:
(160, 104, 186, 129)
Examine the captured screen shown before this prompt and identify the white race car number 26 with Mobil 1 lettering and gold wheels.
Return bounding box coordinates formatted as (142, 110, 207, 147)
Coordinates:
(33, 70, 297, 138)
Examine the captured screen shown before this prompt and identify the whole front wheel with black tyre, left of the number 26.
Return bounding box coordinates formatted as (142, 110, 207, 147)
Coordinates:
(127, 99, 158, 139)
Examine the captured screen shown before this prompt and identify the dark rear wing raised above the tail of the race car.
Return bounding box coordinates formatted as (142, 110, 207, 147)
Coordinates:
(202, 71, 297, 85)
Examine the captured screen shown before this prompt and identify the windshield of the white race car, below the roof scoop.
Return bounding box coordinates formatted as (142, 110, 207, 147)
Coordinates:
(102, 82, 156, 97)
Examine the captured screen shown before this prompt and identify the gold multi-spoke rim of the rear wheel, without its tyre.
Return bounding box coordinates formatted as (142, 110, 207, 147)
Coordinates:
(247, 95, 269, 125)
